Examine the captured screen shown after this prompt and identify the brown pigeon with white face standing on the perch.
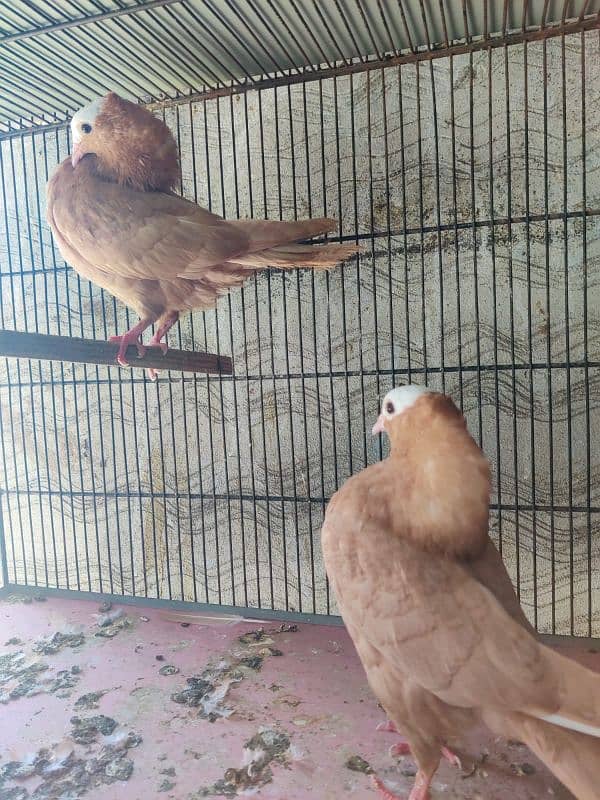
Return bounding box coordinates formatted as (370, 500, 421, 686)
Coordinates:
(47, 93, 357, 380)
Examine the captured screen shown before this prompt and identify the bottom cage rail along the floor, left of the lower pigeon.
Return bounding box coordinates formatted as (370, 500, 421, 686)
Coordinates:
(0, 583, 344, 627)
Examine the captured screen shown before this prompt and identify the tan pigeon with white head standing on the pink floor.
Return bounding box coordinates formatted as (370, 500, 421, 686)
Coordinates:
(322, 386, 600, 800)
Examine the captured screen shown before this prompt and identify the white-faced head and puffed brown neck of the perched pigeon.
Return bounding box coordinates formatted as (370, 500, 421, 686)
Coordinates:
(71, 92, 179, 192)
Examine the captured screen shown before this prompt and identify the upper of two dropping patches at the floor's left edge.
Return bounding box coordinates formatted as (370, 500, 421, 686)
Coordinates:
(0, 650, 81, 704)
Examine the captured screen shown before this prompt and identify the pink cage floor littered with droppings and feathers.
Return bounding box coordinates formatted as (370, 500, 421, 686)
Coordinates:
(0, 598, 600, 800)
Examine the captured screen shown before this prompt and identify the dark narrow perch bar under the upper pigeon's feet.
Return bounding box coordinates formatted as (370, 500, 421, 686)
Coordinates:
(0, 330, 233, 375)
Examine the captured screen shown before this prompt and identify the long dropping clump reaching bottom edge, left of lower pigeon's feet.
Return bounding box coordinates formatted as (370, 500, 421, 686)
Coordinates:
(197, 728, 290, 800)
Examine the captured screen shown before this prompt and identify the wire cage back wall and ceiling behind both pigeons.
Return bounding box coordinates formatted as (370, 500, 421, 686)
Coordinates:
(0, 0, 600, 636)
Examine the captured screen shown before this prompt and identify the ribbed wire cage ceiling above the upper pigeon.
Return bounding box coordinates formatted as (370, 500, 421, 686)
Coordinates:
(0, 0, 600, 131)
